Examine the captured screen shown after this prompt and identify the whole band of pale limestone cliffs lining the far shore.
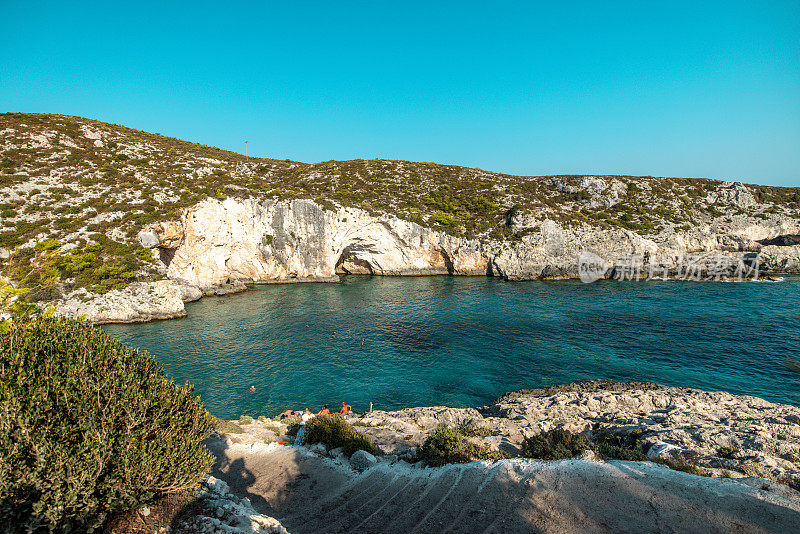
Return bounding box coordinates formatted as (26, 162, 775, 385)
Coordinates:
(51, 198, 800, 323)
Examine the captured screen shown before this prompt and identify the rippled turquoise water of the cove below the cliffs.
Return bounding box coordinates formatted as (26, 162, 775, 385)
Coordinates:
(104, 277, 800, 418)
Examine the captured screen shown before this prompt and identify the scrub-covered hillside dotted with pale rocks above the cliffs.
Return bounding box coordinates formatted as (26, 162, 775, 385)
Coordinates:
(0, 113, 800, 320)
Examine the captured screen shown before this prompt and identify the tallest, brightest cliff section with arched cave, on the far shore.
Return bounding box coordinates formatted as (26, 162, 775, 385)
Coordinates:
(152, 198, 488, 292)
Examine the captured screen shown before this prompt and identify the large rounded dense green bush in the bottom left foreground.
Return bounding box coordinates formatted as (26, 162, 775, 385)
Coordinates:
(0, 318, 211, 531)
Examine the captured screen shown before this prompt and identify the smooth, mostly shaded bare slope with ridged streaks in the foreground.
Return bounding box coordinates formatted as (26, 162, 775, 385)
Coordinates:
(209, 439, 800, 534)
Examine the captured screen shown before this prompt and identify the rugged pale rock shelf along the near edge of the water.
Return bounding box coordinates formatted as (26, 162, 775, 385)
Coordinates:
(217, 380, 800, 490)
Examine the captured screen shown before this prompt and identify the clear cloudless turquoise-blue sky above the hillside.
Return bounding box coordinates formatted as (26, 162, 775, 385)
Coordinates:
(0, 0, 800, 186)
